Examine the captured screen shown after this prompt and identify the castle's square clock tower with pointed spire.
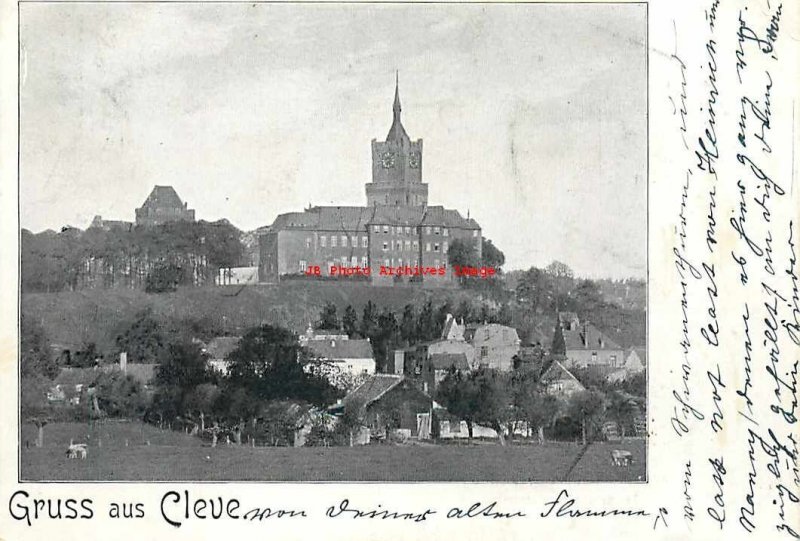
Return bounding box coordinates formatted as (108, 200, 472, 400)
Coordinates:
(366, 76, 428, 207)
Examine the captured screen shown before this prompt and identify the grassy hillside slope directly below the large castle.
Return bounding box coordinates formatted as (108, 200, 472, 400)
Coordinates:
(22, 281, 474, 350)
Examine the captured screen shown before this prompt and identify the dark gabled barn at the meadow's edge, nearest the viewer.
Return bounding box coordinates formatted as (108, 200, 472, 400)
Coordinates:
(334, 374, 433, 439)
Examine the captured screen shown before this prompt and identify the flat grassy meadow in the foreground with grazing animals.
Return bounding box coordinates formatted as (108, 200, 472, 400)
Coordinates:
(21, 422, 645, 482)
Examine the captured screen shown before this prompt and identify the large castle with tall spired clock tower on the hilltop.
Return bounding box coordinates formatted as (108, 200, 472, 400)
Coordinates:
(259, 78, 482, 287)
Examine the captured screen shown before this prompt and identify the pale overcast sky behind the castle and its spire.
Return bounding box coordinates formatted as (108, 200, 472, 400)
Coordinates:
(20, 3, 646, 277)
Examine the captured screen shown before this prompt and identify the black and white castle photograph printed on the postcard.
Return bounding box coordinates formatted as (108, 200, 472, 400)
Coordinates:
(18, 2, 650, 484)
